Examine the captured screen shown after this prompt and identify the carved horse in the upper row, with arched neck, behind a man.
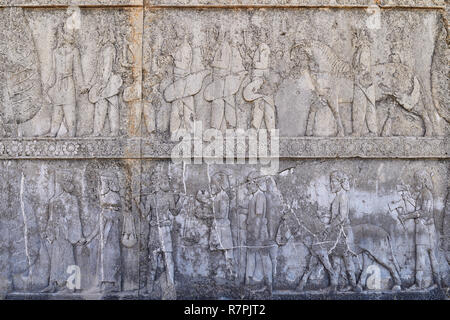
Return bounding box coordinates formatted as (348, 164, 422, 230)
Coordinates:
(290, 40, 433, 136)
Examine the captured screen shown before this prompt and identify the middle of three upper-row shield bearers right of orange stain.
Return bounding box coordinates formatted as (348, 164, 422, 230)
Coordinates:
(204, 33, 246, 130)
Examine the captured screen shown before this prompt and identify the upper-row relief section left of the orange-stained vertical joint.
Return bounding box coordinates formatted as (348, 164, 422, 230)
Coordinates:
(0, 7, 142, 138)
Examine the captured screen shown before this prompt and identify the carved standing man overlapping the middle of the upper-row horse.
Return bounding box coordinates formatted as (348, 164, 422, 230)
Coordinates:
(352, 29, 378, 136)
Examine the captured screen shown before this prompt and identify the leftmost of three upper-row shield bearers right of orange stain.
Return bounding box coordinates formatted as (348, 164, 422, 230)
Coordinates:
(164, 30, 207, 139)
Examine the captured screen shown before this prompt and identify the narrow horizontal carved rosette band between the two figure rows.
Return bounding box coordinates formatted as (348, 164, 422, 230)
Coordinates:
(0, 137, 444, 160)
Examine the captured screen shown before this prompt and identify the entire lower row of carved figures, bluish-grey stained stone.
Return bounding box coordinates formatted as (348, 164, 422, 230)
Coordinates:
(1, 162, 450, 299)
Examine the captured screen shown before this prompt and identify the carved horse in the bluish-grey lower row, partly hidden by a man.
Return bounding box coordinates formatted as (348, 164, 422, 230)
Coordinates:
(278, 210, 401, 291)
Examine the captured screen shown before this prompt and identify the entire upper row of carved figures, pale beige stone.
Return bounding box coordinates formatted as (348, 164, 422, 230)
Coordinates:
(0, 7, 450, 137)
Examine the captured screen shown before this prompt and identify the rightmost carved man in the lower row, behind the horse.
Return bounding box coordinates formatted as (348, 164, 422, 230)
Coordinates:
(399, 169, 442, 290)
